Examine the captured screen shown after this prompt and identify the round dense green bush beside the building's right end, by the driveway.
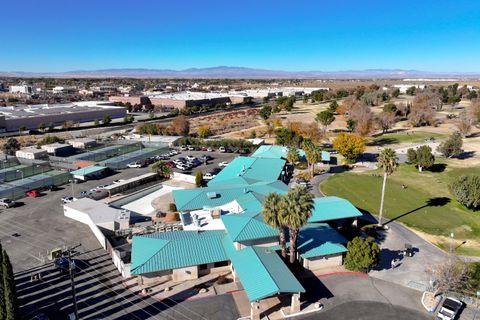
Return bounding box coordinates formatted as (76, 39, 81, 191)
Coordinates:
(345, 237, 380, 272)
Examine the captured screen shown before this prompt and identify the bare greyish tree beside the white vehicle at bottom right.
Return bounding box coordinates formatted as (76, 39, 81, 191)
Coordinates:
(426, 258, 471, 296)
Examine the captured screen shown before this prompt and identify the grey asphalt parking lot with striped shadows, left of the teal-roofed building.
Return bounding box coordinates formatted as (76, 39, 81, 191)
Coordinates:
(0, 151, 244, 319)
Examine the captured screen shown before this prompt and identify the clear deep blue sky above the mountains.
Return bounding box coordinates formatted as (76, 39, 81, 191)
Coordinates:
(0, 0, 480, 72)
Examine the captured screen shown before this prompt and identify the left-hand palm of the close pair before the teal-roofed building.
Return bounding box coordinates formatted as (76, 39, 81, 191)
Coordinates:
(262, 192, 287, 258)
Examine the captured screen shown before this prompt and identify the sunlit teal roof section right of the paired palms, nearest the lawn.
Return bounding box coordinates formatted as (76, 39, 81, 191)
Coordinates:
(308, 197, 362, 222)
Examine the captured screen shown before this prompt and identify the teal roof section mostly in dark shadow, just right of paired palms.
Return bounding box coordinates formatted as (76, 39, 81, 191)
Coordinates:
(297, 223, 347, 259)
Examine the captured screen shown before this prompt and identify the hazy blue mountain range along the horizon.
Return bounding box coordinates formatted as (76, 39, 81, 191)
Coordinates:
(0, 66, 480, 79)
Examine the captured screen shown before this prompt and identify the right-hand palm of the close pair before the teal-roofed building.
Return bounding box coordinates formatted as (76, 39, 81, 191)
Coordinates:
(283, 186, 313, 264)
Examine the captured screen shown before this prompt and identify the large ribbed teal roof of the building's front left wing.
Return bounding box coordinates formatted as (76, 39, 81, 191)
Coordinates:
(131, 230, 229, 275)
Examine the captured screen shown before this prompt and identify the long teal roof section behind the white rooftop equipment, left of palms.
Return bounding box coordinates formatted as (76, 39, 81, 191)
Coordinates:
(172, 180, 288, 210)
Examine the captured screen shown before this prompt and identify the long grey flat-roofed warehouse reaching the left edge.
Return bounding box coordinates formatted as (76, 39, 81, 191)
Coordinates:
(0, 101, 126, 132)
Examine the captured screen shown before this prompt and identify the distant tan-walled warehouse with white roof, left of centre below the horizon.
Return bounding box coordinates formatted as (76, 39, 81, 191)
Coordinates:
(109, 91, 250, 109)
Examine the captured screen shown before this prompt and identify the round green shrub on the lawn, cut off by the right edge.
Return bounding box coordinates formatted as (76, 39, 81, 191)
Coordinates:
(450, 175, 480, 209)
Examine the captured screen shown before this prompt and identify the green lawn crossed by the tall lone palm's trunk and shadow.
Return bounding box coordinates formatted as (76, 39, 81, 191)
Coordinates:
(320, 160, 480, 255)
